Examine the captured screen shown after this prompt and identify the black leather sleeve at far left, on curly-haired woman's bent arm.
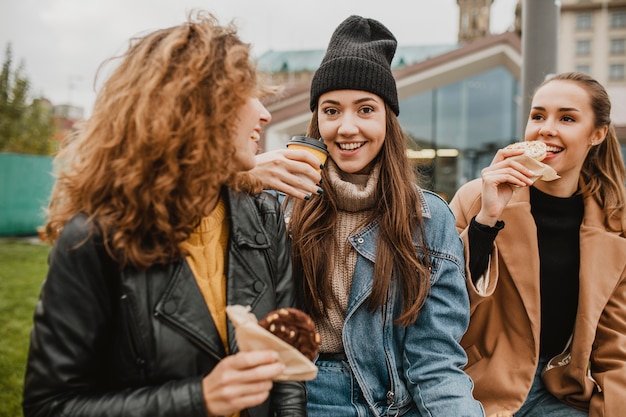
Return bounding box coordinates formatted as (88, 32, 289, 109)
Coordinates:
(23, 217, 206, 417)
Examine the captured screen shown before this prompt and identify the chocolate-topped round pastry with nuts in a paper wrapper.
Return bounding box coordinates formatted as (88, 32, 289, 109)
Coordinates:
(259, 308, 321, 360)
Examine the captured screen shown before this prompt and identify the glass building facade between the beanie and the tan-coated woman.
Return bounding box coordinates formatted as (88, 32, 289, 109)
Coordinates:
(399, 67, 522, 201)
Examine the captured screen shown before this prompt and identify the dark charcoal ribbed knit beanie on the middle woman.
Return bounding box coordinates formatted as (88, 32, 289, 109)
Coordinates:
(310, 16, 400, 116)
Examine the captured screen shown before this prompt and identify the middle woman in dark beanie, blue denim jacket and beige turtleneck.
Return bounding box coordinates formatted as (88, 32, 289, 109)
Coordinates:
(250, 16, 484, 417)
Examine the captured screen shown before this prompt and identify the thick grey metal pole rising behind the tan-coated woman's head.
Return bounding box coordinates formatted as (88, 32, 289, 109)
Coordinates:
(520, 0, 561, 138)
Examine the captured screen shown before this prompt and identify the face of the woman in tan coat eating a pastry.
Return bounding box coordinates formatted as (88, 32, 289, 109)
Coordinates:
(524, 80, 607, 195)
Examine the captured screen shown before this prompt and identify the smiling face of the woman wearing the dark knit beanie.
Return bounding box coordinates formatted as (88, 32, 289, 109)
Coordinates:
(317, 90, 387, 174)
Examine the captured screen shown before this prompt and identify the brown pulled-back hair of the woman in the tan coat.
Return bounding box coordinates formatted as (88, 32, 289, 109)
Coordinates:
(538, 72, 626, 236)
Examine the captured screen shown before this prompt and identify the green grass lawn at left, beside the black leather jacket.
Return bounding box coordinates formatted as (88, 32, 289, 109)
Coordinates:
(0, 238, 50, 417)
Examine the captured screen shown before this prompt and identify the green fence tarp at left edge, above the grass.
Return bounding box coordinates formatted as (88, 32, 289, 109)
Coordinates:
(0, 152, 54, 236)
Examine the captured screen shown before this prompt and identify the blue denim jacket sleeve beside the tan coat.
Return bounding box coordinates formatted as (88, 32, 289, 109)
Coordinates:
(405, 196, 484, 417)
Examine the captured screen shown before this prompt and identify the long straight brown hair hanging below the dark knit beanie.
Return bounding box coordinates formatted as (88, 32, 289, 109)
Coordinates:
(288, 105, 430, 326)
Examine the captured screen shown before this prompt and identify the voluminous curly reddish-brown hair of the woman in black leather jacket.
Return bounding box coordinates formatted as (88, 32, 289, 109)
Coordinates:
(46, 11, 273, 269)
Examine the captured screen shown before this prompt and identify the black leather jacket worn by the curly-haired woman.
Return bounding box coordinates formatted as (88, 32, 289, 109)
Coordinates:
(23, 191, 306, 417)
